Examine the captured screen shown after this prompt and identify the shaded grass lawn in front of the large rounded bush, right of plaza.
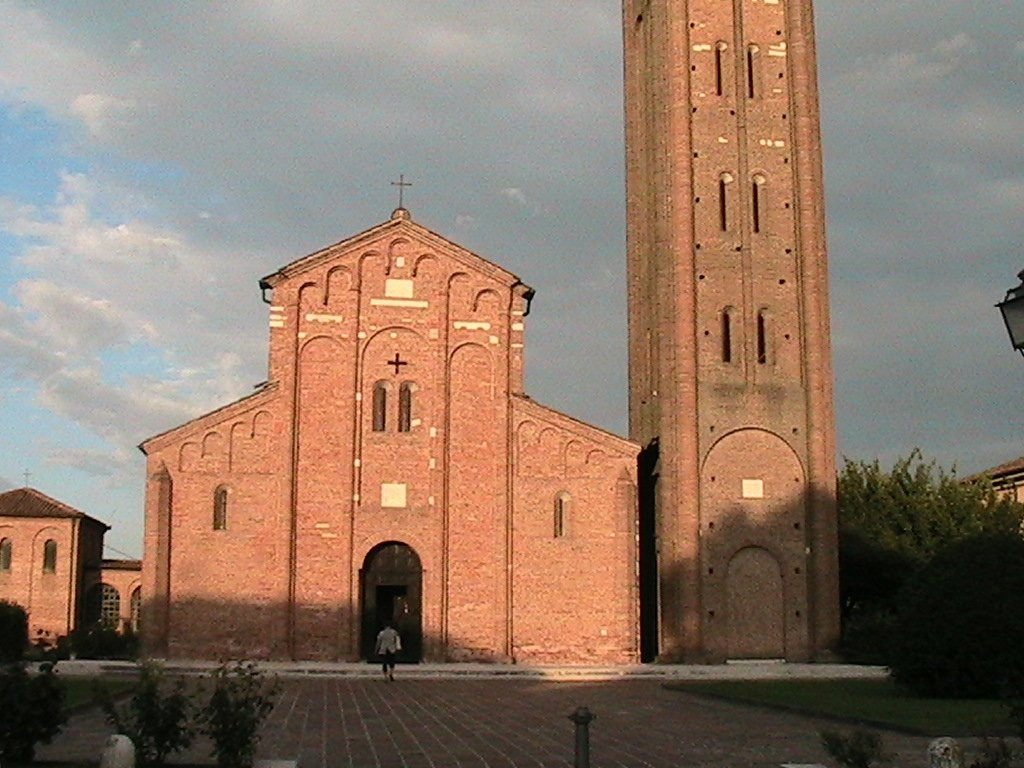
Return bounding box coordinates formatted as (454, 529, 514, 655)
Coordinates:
(669, 680, 1015, 736)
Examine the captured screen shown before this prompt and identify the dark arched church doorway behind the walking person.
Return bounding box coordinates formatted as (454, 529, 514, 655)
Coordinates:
(359, 542, 423, 663)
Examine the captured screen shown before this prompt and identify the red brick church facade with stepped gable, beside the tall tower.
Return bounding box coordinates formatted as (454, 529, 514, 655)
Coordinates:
(140, 208, 639, 663)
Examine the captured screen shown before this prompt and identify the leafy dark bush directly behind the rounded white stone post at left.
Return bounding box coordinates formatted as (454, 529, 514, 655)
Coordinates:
(97, 663, 194, 768)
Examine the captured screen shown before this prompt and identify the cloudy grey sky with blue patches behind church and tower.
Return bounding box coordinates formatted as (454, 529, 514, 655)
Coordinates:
(0, 0, 1024, 557)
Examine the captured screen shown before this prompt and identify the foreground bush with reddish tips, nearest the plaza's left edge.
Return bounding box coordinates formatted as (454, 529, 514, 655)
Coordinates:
(200, 662, 279, 768)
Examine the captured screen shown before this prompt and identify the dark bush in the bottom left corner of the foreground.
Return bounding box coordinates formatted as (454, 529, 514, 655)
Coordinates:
(0, 664, 68, 764)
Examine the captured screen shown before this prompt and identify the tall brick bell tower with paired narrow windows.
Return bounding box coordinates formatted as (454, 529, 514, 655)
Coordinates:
(623, 0, 839, 662)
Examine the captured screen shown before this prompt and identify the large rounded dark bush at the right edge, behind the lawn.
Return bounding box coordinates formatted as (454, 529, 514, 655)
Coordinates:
(890, 534, 1024, 697)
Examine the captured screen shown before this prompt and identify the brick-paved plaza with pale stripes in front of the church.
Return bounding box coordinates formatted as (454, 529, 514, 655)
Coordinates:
(38, 668, 938, 768)
